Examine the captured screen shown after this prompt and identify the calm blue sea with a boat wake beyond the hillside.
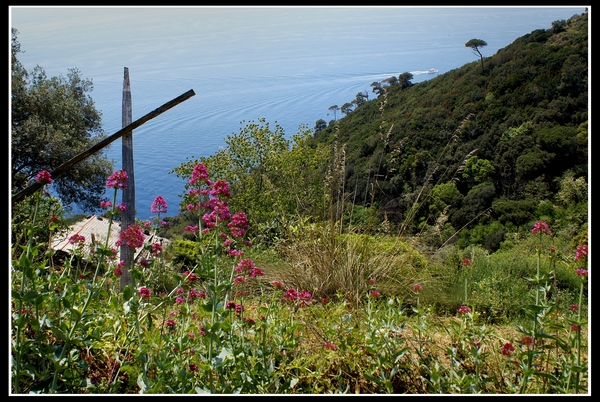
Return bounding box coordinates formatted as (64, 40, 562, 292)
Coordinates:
(11, 7, 584, 219)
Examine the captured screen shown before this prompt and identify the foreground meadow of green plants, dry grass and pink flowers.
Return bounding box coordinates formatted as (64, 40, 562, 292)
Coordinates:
(10, 164, 589, 394)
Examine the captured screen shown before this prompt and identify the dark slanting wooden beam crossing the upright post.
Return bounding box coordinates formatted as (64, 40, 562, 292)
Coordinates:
(12, 89, 196, 205)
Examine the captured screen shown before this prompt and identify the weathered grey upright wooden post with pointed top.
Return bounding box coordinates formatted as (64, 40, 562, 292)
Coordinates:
(120, 67, 135, 291)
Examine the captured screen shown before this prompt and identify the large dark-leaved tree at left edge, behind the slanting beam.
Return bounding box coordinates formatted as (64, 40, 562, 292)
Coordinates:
(11, 28, 113, 211)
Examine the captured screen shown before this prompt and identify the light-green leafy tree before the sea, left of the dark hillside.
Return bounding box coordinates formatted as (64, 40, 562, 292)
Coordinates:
(173, 118, 330, 243)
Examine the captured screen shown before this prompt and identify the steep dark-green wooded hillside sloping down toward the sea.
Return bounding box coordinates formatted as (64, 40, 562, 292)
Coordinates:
(314, 14, 589, 250)
